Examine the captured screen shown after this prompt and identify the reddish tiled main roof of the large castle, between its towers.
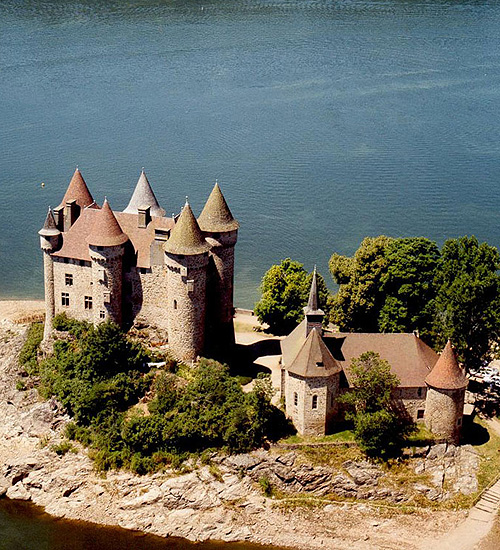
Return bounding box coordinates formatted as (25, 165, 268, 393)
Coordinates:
(53, 208, 174, 268)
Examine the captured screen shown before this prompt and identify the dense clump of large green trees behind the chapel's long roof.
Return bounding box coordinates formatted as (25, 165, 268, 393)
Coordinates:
(330, 235, 500, 367)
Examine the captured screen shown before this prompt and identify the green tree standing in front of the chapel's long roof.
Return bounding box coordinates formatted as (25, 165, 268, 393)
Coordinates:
(340, 351, 415, 458)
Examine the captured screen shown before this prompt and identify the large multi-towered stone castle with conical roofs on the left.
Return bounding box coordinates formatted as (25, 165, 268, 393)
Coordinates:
(39, 168, 239, 360)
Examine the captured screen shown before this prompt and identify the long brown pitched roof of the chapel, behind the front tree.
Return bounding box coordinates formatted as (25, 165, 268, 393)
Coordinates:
(325, 332, 439, 388)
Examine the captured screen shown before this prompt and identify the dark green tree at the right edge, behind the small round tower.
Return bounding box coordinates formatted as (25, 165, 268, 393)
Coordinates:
(434, 236, 500, 368)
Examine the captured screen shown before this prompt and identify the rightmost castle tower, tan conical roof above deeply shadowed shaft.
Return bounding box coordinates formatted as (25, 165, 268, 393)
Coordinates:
(198, 183, 239, 355)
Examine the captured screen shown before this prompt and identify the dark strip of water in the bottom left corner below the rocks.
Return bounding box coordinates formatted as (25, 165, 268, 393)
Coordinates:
(0, 499, 279, 550)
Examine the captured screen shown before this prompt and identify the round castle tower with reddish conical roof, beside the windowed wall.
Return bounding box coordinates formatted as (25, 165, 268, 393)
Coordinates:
(87, 199, 128, 325)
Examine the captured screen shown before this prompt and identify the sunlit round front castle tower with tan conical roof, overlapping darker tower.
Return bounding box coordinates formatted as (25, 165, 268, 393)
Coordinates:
(164, 200, 210, 361)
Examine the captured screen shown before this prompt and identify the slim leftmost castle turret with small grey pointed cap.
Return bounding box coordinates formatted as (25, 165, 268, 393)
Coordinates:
(38, 207, 61, 340)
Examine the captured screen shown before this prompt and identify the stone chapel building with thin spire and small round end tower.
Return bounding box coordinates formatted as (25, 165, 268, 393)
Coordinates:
(281, 271, 467, 443)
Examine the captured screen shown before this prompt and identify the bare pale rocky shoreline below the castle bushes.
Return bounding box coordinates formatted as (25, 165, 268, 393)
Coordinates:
(0, 301, 474, 550)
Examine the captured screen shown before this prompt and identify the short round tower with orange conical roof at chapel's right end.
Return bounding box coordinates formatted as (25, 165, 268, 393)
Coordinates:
(424, 340, 467, 444)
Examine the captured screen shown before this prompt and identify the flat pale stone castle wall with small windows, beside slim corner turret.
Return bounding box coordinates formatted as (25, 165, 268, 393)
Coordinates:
(53, 258, 96, 322)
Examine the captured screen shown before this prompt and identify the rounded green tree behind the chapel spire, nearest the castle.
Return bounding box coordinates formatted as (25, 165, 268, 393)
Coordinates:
(254, 258, 330, 334)
